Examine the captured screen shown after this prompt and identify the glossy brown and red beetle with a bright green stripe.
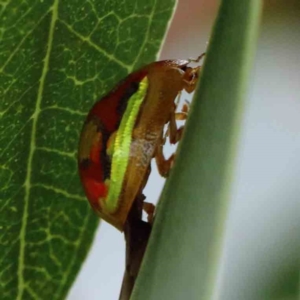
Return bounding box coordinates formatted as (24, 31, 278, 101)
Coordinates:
(78, 54, 204, 231)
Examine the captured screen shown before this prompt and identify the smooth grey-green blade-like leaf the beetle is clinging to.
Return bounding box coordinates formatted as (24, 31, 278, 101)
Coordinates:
(132, 0, 261, 300)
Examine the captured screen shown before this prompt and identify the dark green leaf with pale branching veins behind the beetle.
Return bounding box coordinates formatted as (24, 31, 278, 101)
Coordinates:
(0, 0, 175, 300)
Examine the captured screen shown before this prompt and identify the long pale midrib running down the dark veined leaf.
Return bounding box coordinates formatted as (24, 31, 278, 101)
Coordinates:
(16, 0, 58, 300)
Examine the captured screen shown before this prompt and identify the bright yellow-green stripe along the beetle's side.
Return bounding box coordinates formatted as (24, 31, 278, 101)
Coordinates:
(99, 77, 148, 213)
